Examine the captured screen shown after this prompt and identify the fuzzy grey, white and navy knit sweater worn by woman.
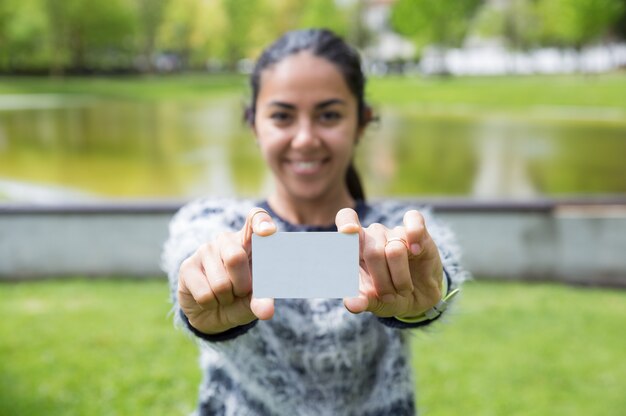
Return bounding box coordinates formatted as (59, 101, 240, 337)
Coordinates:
(162, 199, 465, 416)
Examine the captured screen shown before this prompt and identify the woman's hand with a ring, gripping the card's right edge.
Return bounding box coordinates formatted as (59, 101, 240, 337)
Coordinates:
(335, 208, 443, 318)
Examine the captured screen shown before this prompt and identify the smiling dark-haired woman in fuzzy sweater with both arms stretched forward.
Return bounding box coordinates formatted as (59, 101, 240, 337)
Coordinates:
(163, 30, 464, 415)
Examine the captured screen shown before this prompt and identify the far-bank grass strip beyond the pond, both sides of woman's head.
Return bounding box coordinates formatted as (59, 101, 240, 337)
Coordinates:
(0, 73, 626, 117)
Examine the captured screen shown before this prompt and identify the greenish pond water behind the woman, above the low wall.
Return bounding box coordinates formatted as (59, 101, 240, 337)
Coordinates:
(0, 96, 626, 201)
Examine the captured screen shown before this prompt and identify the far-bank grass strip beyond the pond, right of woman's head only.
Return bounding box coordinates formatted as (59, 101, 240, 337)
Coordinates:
(369, 73, 626, 115)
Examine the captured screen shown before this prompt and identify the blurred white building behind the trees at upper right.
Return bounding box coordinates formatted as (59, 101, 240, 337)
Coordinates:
(355, 0, 626, 75)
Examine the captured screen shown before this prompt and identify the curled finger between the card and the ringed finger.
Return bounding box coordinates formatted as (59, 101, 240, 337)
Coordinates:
(363, 224, 396, 303)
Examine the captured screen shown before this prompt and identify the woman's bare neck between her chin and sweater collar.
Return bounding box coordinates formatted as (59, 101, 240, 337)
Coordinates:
(268, 190, 355, 226)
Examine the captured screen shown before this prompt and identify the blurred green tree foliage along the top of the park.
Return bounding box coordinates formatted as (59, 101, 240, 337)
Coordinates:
(0, 0, 626, 74)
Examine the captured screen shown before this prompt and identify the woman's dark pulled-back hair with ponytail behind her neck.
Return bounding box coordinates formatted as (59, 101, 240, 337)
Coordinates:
(245, 29, 371, 200)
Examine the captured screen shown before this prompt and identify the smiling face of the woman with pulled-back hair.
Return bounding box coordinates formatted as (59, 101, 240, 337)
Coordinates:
(254, 51, 362, 205)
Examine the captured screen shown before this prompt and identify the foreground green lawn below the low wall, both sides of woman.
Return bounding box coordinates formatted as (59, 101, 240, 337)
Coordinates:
(0, 279, 626, 416)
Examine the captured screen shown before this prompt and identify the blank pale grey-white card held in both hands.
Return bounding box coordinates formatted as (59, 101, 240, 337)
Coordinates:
(252, 232, 359, 299)
